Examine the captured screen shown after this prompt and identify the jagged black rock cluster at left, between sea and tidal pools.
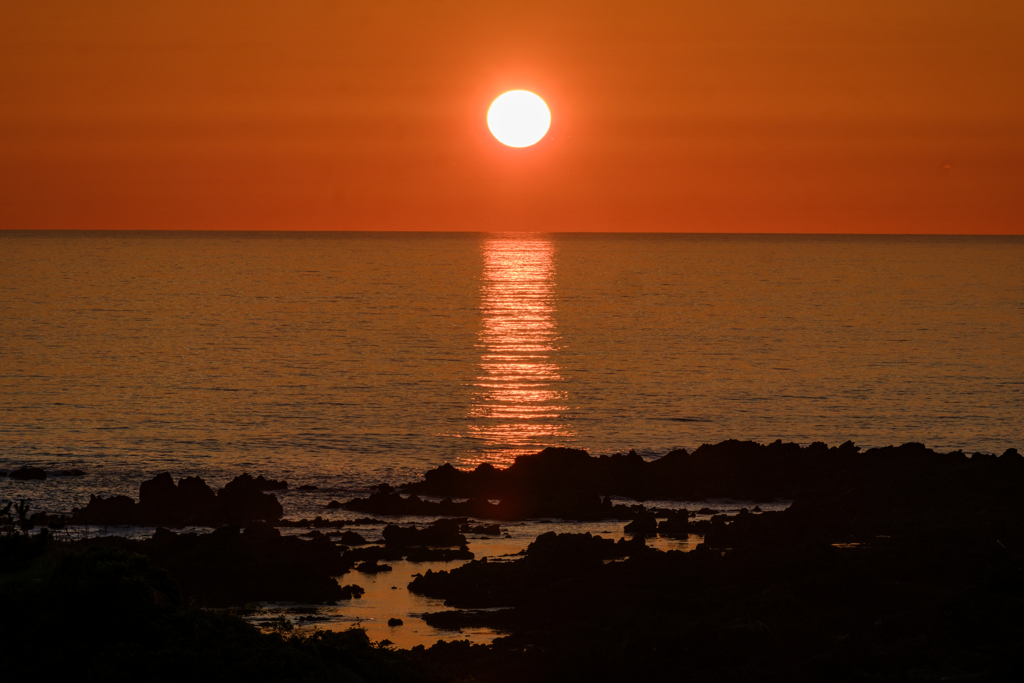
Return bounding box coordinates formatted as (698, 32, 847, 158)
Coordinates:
(71, 472, 287, 526)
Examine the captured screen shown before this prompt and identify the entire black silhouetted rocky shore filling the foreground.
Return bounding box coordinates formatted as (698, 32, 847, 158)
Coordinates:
(0, 441, 1024, 683)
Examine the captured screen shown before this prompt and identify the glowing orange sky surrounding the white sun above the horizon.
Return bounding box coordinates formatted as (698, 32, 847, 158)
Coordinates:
(0, 0, 1024, 234)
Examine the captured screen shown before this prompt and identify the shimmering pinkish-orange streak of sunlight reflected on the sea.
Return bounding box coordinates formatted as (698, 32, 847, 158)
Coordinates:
(463, 234, 574, 466)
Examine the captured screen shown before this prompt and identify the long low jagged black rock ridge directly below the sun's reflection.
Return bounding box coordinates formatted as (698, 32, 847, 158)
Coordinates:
(380, 440, 1024, 520)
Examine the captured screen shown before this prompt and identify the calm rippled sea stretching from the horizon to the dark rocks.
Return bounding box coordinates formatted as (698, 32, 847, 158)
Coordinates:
(0, 231, 1024, 509)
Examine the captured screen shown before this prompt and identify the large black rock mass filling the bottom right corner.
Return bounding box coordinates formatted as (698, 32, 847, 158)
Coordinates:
(399, 443, 1024, 683)
